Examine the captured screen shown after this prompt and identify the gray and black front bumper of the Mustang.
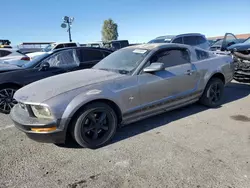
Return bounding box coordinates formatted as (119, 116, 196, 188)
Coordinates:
(10, 105, 66, 143)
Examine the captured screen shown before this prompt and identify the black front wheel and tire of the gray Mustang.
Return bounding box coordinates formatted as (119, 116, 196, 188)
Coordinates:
(71, 102, 117, 149)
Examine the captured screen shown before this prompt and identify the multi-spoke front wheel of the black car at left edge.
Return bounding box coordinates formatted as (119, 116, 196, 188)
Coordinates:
(0, 88, 17, 114)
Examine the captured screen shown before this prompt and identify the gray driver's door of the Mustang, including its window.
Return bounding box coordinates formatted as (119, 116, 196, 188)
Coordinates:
(138, 48, 198, 111)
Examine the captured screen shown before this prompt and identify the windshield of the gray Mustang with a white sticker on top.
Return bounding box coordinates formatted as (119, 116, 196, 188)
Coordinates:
(93, 48, 149, 74)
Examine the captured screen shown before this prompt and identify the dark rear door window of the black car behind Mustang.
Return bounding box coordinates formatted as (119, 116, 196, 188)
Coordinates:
(77, 49, 103, 62)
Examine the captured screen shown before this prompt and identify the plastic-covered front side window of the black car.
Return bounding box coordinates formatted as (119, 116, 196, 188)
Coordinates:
(43, 50, 80, 67)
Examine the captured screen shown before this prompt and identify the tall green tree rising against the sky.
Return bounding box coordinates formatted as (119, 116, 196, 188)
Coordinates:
(102, 19, 119, 42)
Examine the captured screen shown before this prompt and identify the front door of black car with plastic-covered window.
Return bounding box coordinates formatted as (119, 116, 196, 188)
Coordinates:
(22, 49, 80, 85)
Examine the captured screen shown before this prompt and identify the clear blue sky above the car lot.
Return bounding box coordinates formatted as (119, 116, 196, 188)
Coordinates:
(0, 0, 250, 44)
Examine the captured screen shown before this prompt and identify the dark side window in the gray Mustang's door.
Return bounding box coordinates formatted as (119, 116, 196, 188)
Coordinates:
(151, 49, 190, 68)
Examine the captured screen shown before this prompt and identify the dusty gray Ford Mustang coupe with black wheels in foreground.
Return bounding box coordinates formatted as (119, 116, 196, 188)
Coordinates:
(10, 43, 234, 148)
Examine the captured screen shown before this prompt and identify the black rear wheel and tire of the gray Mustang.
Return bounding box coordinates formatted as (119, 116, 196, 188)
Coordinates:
(199, 78, 225, 108)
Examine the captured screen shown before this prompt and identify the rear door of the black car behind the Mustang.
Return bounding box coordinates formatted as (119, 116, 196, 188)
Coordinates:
(77, 48, 105, 69)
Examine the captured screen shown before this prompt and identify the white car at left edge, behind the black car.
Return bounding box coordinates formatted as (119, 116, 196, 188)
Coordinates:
(0, 48, 30, 66)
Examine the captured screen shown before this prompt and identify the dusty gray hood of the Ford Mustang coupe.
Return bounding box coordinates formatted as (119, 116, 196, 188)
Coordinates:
(14, 69, 125, 103)
